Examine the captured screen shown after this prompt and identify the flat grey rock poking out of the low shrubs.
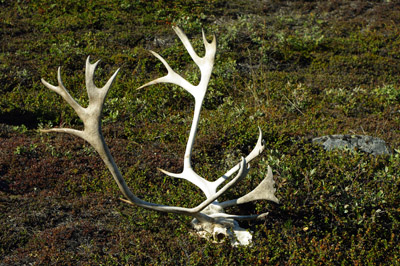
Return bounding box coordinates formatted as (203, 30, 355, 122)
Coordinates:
(312, 135, 392, 155)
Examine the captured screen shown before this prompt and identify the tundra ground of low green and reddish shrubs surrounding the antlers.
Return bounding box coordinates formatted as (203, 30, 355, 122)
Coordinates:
(0, 0, 400, 265)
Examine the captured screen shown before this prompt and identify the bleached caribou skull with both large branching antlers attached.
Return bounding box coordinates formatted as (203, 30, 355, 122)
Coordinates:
(41, 27, 279, 245)
